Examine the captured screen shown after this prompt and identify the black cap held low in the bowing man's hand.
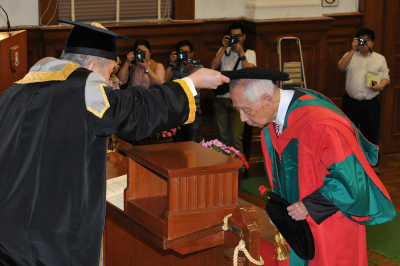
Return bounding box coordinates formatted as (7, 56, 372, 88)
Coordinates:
(265, 192, 315, 260)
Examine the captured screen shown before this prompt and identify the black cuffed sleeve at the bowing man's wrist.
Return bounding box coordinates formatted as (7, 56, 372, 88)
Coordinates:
(302, 190, 339, 224)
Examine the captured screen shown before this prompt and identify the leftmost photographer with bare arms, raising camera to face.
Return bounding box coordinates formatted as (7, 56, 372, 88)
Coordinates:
(117, 39, 165, 87)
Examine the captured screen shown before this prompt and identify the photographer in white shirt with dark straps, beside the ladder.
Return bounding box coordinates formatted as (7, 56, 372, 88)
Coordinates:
(211, 23, 257, 152)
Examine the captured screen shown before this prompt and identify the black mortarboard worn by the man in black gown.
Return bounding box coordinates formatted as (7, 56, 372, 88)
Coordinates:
(58, 19, 131, 61)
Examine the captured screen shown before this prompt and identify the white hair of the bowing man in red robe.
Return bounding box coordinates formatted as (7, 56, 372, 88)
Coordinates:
(230, 79, 275, 102)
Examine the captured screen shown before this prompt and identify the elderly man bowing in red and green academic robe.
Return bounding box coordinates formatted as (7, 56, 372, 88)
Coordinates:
(227, 68, 396, 266)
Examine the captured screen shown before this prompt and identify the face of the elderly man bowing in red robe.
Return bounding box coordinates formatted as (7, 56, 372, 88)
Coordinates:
(231, 87, 274, 128)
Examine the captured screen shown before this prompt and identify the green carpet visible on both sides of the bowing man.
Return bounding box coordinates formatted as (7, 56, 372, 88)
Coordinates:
(239, 176, 400, 263)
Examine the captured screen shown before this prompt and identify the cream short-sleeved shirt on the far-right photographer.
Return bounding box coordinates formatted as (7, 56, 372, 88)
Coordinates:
(339, 51, 389, 100)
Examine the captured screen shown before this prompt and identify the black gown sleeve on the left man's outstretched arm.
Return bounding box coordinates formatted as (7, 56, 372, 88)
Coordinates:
(91, 82, 196, 141)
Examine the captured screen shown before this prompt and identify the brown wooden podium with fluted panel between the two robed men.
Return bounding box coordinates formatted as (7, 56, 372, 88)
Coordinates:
(104, 142, 260, 266)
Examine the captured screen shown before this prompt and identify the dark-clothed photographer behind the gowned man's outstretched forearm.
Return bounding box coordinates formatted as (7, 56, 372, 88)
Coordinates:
(165, 40, 203, 142)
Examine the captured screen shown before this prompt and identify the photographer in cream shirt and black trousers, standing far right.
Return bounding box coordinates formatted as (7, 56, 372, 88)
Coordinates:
(339, 28, 389, 174)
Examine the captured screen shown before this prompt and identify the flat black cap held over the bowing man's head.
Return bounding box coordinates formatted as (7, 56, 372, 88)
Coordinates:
(221, 67, 289, 81)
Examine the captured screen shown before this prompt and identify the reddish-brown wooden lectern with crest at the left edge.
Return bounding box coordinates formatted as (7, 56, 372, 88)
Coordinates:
(0, 30, 28, 95)
